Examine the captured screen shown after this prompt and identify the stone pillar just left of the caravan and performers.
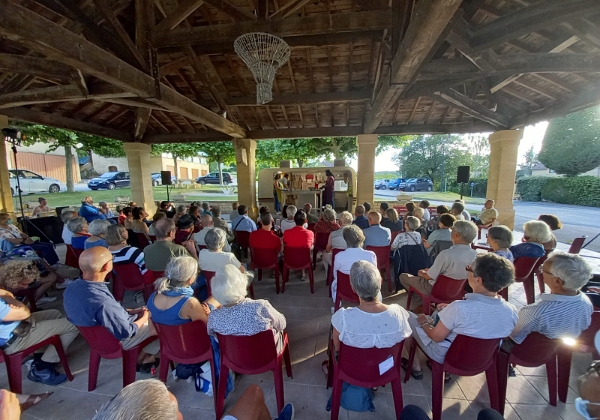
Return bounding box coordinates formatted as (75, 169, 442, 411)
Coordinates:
(233, 139, 258, 219)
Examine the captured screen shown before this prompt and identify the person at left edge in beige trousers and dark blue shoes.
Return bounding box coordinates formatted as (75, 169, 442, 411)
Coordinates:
(0, 278, 77, 386)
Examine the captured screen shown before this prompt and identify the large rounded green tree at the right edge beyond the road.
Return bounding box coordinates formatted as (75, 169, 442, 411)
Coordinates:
(538, 107, 600, 176)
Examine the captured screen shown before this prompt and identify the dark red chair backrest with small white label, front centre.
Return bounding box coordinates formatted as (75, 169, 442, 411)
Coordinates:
(337, 341, 404, 388)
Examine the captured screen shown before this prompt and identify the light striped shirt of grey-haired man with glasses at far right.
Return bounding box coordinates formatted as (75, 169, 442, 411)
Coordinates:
(510, 292, 594, 344)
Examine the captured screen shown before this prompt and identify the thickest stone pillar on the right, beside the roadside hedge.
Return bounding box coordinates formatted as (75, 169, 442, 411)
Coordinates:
(487, 130, 523, 229)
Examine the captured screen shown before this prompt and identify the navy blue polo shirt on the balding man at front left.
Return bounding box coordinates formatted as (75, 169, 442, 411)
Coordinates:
(63, 279, 138, 341)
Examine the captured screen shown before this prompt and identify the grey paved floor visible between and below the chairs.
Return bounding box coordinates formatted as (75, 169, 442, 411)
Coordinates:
(8, 245, 592, 420)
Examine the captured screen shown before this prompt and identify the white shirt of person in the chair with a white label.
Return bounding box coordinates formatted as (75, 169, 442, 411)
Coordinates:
(331, 304, 412, 349)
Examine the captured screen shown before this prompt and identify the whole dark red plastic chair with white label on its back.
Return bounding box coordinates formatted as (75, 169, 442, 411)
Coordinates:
(331, 342, 404, 420)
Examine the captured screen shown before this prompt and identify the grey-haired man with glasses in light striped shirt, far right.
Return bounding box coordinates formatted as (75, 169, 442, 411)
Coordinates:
(502, 251, 594, 348)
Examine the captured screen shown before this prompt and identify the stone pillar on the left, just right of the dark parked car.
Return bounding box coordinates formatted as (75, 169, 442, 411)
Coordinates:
(123, 143, 156, 215)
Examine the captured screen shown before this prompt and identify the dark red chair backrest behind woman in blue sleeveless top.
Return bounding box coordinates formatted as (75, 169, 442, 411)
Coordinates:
(154, 320, 212, 360)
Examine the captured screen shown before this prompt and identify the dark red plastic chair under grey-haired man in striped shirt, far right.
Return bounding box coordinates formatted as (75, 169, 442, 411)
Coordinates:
(498, 332, 560, 415)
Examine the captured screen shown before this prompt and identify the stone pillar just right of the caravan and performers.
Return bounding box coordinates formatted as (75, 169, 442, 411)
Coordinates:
(355, 134, 377, 204)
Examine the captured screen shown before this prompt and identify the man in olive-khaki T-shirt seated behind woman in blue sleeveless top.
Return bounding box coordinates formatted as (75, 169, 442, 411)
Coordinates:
(144, 219, 197, 272)
